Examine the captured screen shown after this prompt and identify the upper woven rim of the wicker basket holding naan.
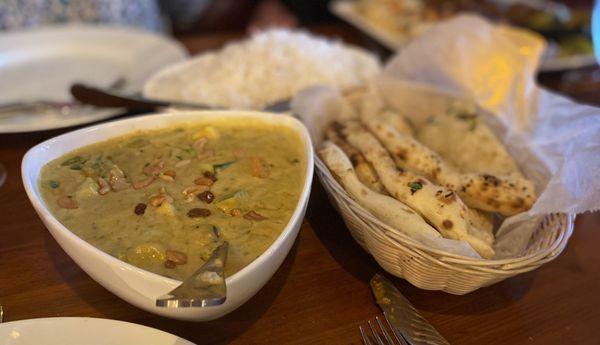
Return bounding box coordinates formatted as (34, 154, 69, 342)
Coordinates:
(315, 152, 575, 266)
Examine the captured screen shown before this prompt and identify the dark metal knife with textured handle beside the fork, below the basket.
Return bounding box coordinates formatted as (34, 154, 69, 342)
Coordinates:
(371, 274, 450, 345)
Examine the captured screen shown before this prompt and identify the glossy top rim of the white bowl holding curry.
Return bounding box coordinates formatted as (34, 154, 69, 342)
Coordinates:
(21, 110, 314, 286)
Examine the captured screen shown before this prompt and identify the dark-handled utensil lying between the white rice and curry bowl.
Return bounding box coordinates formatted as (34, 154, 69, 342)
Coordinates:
(71, 83, 290, 113)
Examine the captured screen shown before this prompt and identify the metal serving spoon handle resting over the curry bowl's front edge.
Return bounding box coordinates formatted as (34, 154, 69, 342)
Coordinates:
(156, 242, 229, 308)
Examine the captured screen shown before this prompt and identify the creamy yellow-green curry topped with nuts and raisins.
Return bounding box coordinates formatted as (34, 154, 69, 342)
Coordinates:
(39, 119, 306, 279)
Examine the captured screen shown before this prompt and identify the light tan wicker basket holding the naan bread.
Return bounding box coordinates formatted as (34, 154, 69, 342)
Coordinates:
(315, 157, 575, 295)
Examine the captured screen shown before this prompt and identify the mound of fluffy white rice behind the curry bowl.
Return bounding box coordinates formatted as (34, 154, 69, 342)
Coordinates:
(144, 29, 381, 109)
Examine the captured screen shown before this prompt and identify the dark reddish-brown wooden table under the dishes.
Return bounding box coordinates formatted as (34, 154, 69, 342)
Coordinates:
(0, 23, 600, 344)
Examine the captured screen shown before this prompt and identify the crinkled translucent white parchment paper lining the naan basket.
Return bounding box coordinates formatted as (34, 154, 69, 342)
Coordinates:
(292, 15, 600, 258)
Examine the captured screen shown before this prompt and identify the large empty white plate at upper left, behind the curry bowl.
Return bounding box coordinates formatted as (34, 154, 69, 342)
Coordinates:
(0, 25, 187, 133)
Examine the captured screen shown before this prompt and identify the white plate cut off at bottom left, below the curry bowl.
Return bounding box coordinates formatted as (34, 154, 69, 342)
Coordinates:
(0, 317, 194, 345)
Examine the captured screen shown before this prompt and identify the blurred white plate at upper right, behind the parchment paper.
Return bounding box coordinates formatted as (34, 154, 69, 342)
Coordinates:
(330, 0, 596, 72)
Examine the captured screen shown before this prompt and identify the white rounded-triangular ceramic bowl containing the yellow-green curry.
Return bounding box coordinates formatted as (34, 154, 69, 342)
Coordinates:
(21, 111, 313, 321)
